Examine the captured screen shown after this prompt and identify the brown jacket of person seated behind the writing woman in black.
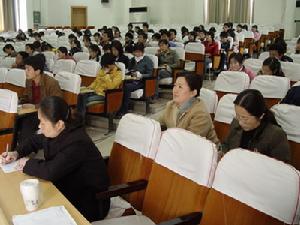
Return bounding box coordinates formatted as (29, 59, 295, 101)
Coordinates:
(22, 74, 63, 103)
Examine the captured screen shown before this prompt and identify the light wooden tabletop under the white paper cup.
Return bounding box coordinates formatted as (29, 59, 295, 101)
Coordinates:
(0, 169, 90, 225)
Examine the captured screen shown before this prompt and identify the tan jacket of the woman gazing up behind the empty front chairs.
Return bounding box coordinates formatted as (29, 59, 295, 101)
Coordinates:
(159, 99, 219, 144)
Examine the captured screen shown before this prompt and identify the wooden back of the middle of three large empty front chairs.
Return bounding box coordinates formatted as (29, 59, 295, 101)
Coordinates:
(142, 163, 209, 224)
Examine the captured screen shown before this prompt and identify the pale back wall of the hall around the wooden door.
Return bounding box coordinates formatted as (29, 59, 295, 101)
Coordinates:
(27, 0, 300, 39)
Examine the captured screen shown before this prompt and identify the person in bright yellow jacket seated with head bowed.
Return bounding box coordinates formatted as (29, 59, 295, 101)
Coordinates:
(77, 53, 122, 119)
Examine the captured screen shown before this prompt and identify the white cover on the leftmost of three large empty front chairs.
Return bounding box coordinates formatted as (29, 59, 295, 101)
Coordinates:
(115, 113, 161, 159)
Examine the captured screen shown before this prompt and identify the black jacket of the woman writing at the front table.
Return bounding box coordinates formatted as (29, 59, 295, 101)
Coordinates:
(17, 126, 109, 221)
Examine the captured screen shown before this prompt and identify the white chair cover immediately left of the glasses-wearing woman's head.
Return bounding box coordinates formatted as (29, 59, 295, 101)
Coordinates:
(215, 94, 237, 124)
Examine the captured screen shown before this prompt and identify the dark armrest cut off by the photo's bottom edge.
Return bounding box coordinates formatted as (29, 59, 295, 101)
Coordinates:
(159, 212, 202, 225)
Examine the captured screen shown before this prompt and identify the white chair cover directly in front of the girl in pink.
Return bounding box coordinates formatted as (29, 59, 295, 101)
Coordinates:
(215, 71, 250, 93)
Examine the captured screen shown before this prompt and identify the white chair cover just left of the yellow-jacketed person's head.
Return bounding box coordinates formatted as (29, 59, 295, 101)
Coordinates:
(74, 60, 100, 77)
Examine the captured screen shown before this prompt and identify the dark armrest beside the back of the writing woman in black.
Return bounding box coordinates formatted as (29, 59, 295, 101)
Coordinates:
(96, 180, 148, 199)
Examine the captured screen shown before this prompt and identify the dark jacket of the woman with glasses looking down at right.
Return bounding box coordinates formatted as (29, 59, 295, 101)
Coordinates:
(222, 119, 290, 162)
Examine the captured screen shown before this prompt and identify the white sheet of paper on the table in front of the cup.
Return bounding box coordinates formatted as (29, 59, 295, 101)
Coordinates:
(12, 206, 77, 225)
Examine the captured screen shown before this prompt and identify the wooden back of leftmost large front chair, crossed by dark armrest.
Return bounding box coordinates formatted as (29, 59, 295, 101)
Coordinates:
(108, 143, 153, 210)
